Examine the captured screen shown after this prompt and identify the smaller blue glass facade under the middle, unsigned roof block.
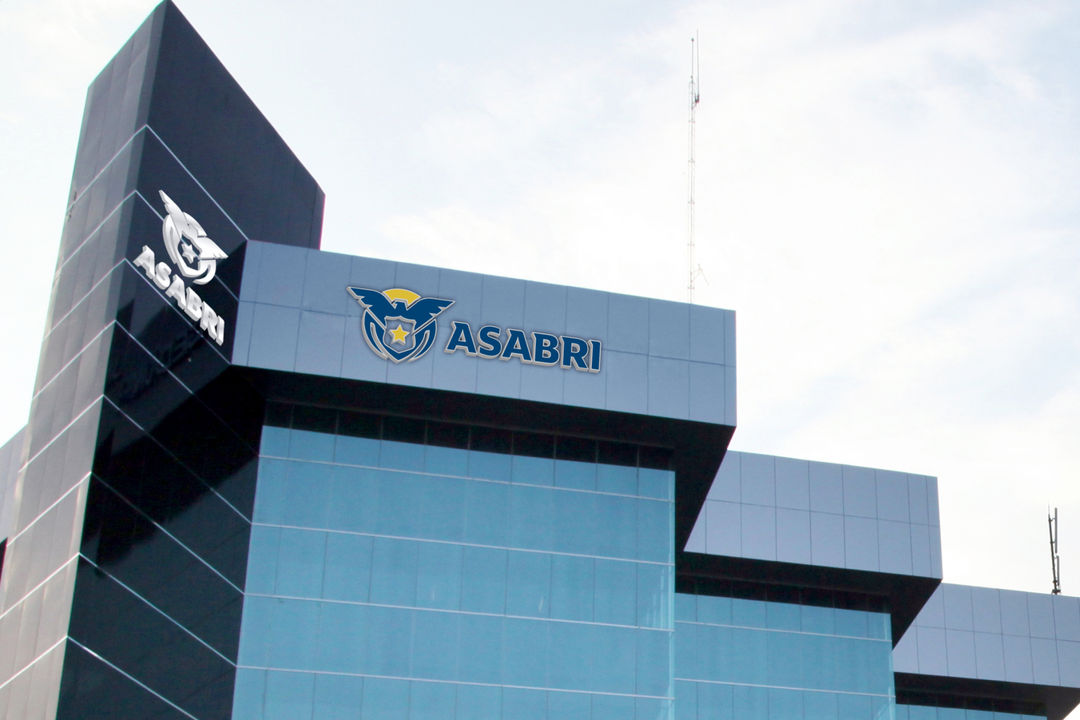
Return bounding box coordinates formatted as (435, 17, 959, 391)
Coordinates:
(675, 593, 895, 720)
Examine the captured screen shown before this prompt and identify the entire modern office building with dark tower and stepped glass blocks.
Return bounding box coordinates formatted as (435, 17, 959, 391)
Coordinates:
(0, 2, 1080, 720)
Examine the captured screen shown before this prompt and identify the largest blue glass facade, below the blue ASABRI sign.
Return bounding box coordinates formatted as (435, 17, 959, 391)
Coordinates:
(233, 416, 674, 720)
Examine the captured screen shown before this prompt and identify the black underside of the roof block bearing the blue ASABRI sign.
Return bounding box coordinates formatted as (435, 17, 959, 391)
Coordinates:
(245, 369, 734, 547)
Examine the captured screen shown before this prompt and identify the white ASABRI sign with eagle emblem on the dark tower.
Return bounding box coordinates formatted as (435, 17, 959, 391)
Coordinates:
(134, 190, 229, 345)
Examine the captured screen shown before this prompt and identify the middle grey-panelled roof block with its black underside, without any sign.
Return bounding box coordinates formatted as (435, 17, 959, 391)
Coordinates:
(676, 450, 942, 642)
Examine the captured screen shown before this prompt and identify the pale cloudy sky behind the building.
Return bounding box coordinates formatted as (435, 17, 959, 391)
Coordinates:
(0, 0, 1080, 613)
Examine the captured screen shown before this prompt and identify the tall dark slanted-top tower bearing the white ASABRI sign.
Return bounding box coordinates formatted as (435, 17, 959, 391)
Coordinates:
(0, 1, 323, 720)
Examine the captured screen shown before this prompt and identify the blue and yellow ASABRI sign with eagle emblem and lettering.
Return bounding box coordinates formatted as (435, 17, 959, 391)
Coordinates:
(346, 287, 602, 372)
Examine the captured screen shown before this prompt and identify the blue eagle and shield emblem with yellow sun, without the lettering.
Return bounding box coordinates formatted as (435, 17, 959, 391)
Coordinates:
(346, 287, 454, 363)
